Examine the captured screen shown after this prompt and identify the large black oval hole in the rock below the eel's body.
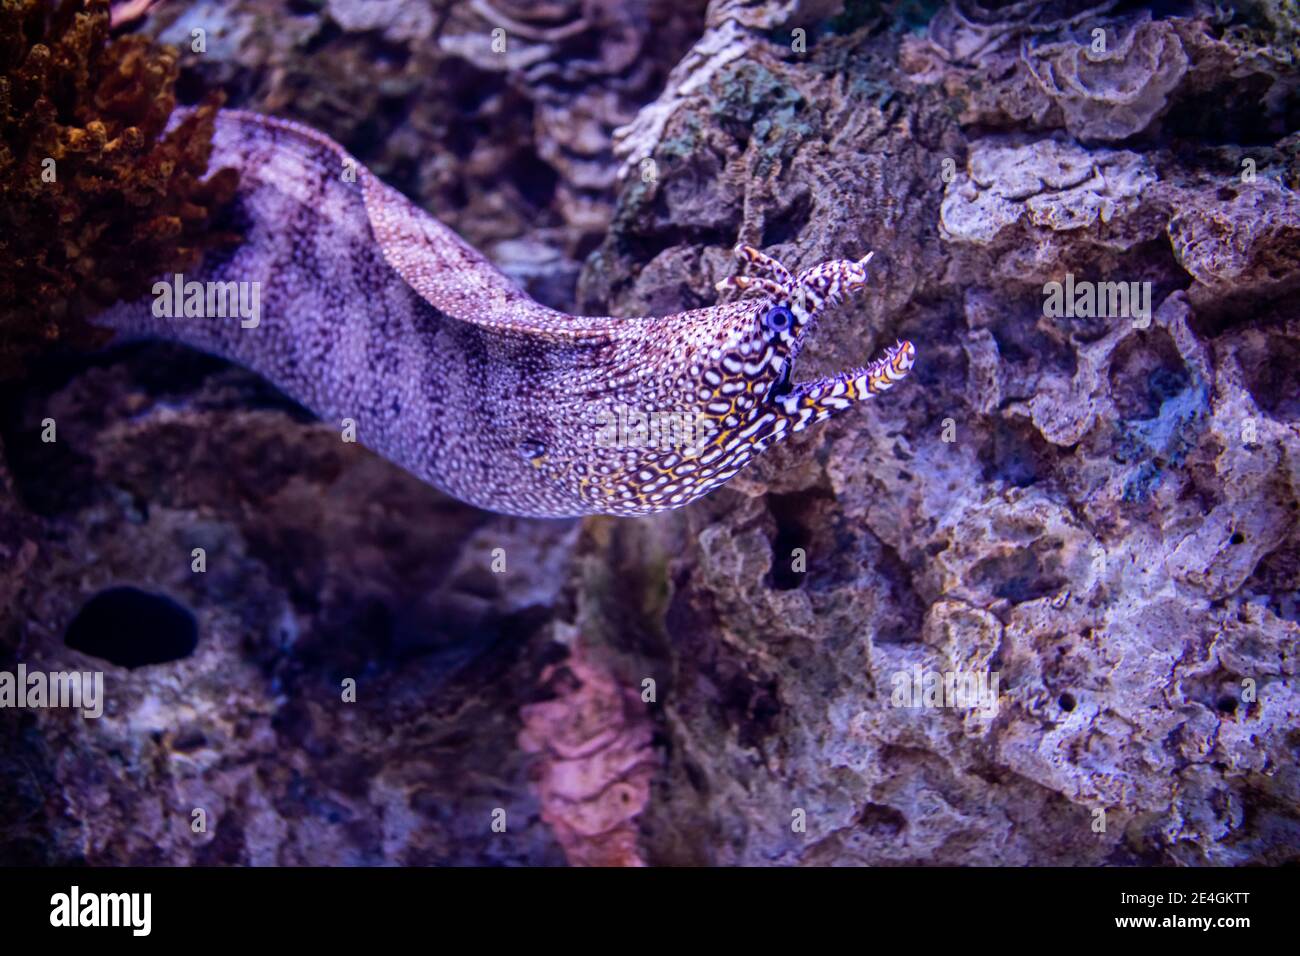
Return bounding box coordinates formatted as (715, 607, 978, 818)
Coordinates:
(64, 588, 199, 667)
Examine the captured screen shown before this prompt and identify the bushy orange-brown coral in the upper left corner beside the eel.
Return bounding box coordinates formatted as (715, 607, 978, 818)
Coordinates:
(0, 0, 238, 377)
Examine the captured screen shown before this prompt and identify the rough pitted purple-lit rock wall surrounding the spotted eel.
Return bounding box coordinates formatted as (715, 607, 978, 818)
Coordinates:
(0, 0, 1300, 865)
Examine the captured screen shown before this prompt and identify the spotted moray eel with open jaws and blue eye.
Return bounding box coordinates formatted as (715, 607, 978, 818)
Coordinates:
(99, 111, 915, 518)
